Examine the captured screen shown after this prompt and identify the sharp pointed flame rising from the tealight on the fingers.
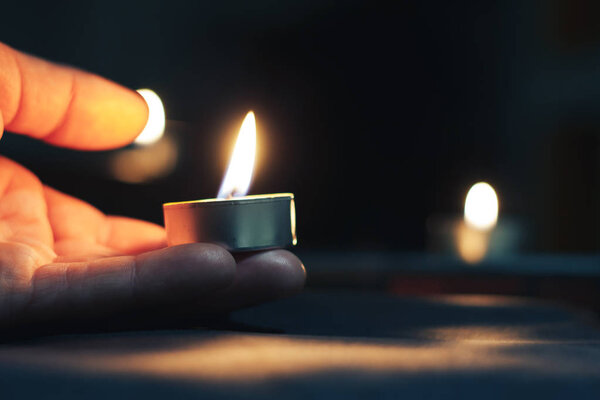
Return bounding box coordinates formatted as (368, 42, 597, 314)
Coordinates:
(217, 111, 256, 199)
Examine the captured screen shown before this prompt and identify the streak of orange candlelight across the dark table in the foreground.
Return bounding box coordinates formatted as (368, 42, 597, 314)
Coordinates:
(0, 334, 540, 383)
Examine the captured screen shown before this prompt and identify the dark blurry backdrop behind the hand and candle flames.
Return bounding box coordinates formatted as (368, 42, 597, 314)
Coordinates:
(0, 0, 600, 252)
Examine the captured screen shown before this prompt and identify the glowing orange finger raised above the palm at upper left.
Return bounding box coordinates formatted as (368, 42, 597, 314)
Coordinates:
(0, 43, 148, 150)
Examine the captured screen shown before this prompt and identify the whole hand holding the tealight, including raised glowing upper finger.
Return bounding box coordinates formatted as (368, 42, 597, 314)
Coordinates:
(0, 43, 305, 326)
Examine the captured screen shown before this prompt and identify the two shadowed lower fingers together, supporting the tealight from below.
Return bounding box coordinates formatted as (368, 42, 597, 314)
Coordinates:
(26, 247, 305, 320)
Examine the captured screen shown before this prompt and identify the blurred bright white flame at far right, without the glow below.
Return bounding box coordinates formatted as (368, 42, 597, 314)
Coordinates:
(465, 182, 498, 231)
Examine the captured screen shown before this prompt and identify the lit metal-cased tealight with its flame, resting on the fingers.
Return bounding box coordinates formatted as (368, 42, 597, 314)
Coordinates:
(163, 111, 296, 251)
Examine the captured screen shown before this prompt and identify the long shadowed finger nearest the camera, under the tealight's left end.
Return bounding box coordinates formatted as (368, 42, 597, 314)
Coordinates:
(27, 243, 236, 319)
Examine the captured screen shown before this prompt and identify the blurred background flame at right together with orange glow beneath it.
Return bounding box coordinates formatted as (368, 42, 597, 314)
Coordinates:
(455, 182, 498, 264)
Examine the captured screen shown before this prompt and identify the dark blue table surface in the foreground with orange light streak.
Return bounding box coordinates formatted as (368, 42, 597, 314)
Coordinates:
(0, 290, 600, 399)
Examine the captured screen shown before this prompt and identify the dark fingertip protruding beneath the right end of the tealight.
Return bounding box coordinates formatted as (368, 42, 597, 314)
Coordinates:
(198, 250, 306, 312)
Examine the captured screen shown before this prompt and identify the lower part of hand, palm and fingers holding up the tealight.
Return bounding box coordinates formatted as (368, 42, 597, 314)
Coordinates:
(0, 158, 304, 322)
